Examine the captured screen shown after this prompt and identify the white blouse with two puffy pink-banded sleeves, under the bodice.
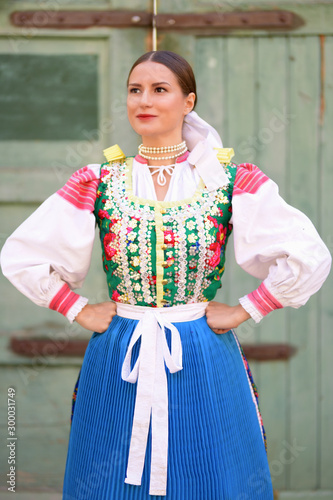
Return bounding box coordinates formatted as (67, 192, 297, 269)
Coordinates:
(1, 158, 331, 322)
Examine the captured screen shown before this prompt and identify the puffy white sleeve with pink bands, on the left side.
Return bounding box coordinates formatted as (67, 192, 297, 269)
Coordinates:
(1, 164, 100, 323)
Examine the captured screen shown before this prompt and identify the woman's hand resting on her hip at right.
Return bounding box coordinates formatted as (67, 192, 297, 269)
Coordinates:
(206, 301, 251, 333)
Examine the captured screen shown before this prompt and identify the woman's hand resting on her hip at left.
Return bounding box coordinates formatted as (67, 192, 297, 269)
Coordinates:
(75, 302, 117, 333)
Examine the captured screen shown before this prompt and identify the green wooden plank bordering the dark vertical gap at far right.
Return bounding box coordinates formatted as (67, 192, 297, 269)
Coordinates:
(286, 37, 320, 490)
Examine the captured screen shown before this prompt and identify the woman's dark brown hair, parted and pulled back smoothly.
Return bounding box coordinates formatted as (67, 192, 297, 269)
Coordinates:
(127, 50, 197, 109)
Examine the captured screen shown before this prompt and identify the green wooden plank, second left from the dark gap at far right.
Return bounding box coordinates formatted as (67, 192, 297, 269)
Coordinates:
(252, 37, 290, 489)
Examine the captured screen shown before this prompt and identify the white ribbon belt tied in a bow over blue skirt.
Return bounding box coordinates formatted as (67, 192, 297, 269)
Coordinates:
(117, 302, 208, 495)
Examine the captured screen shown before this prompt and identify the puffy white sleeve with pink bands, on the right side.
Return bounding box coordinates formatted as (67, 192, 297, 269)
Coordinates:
(231, 163, 332, 323)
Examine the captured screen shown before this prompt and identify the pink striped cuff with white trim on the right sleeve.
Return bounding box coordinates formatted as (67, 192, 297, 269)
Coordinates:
(239, 283, 283, 323)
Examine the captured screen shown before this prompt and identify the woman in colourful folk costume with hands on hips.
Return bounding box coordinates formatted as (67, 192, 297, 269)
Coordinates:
(2, 51, 331, 500)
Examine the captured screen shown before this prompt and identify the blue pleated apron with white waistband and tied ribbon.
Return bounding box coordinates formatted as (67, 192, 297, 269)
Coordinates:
(63, 302, 273, 500)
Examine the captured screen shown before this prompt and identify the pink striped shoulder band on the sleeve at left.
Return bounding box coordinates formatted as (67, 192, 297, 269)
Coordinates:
(58, 167, 99, 211)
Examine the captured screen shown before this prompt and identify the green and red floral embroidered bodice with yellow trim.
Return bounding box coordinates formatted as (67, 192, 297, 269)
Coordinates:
(95, 158, 236, 307)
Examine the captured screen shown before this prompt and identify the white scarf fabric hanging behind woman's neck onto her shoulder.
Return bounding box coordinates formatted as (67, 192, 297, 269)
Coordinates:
(183, 111, 228, 191)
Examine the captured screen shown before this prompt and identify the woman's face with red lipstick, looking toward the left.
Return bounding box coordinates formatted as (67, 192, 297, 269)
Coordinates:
(127, 61, 195, 144)
